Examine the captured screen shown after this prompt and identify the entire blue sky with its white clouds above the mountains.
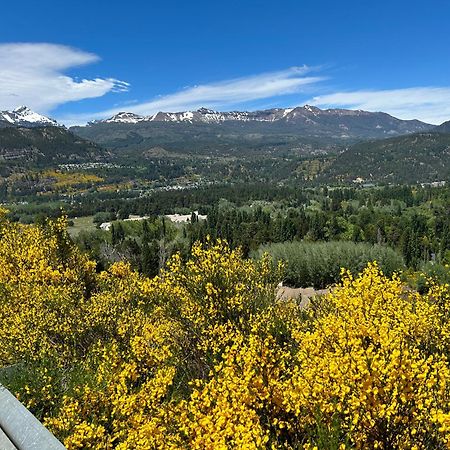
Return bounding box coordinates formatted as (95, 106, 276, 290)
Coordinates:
(0, 0, 450, 124)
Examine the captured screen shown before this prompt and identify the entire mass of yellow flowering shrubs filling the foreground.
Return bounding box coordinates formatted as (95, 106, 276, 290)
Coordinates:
(0, 213, 450, 450)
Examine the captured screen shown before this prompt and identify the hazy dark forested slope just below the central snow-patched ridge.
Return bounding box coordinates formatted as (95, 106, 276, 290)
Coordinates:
(71, 122, 335, 158)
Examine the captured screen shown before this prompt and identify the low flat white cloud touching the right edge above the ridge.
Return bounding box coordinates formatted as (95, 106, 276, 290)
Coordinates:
(308, 87, 450, 124)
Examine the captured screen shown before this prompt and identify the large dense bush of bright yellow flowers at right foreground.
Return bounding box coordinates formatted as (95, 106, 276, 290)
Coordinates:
(282, 265, 450, 448)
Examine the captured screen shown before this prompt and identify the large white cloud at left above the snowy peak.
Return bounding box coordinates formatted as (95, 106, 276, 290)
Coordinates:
(0, 43, 129, 113)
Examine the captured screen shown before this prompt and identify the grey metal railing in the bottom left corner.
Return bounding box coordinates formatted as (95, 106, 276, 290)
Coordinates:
(0, 384, 65, 450)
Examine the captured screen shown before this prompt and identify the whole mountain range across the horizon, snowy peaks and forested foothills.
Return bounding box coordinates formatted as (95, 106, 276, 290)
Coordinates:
(0, 105, 450, 183)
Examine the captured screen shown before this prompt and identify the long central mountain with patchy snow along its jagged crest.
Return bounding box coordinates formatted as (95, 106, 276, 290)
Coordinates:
(71, 105, 434, 157)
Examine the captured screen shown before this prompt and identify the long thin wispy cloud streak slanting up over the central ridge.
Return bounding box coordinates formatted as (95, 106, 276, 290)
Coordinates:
(61, 66, 325, 124)
